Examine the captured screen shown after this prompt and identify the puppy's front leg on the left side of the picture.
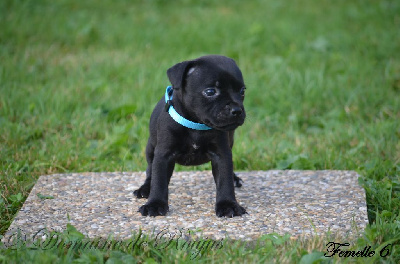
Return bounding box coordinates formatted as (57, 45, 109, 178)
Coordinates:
(139, 148, 175, 216)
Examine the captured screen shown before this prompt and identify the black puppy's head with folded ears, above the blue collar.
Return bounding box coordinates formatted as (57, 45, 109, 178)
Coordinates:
(167, 55, 246, 131)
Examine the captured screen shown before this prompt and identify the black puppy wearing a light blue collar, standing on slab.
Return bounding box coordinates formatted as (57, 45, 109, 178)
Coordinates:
(134, 55, 246, 217)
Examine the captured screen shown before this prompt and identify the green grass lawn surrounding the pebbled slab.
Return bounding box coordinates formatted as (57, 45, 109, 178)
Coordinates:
(0, 0, 400, 263)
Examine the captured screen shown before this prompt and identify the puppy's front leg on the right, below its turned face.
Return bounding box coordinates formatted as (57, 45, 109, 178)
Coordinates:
(210, 148, 246, 217)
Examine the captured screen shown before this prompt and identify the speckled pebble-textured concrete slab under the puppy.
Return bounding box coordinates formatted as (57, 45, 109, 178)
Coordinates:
(3, 171, 367, 241)
